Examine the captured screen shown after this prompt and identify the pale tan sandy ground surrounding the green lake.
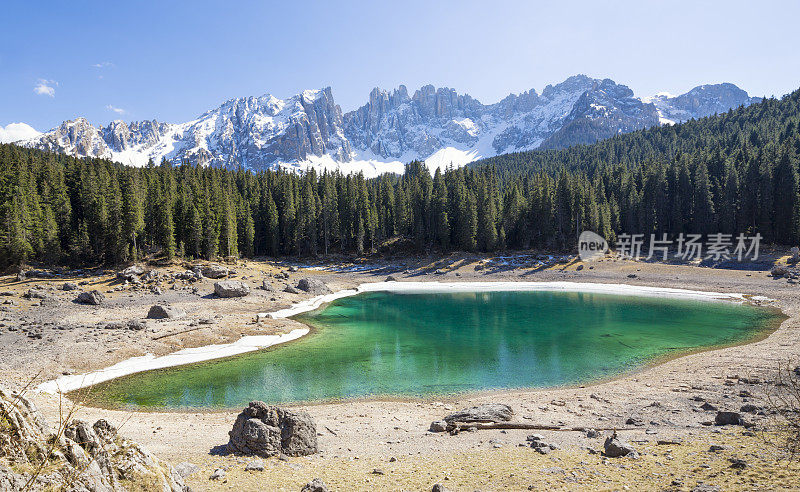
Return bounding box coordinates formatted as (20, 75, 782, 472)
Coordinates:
(0, 252, 800, 490)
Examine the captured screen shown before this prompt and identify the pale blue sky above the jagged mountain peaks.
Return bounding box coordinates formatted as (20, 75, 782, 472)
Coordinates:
(0, 0, 800, 131)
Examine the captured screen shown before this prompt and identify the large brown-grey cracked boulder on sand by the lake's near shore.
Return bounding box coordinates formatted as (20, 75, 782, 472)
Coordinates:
(228, 401, 319, 458)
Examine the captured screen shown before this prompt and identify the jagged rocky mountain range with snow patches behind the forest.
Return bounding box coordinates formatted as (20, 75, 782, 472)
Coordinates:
(14, 75, 759, 175)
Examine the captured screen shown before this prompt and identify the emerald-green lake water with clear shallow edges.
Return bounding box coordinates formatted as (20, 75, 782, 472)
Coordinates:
(84, 292, 779, 409)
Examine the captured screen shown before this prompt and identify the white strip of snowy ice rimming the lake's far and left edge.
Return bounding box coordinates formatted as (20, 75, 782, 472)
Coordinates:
(36, 281, 768, 398)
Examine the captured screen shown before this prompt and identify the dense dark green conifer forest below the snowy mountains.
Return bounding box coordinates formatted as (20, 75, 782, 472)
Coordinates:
(0, 86, 800, 267)
